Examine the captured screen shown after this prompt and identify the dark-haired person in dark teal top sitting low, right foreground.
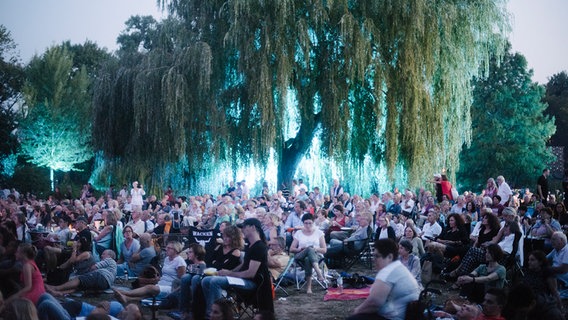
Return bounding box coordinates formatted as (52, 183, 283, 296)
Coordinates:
(456, 244, 507, 303)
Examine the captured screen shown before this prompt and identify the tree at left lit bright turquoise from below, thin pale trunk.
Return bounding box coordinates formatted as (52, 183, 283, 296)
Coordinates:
(18, 46, 92, 190)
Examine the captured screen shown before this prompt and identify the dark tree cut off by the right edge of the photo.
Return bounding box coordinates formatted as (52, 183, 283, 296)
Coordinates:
(544, 71, 568, 158)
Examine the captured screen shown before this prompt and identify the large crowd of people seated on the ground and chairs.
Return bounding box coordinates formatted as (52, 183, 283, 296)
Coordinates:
(0, 170, 568, 319)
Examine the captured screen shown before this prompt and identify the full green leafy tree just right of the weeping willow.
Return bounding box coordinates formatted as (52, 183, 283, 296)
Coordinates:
(458, 46, 556, 191)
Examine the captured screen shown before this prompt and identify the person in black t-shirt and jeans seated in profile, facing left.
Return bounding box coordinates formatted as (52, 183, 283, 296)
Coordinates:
(201, 218, 274, 314)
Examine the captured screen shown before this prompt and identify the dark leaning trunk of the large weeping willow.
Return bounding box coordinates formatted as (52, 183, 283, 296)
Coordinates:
(277, 113, 320, 191)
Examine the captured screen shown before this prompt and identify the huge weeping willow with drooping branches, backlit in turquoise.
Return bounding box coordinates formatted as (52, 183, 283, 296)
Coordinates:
(95, 0, 508, 194)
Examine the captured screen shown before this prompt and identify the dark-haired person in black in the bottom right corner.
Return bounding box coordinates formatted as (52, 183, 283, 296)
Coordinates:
(520, 251, 562, 319)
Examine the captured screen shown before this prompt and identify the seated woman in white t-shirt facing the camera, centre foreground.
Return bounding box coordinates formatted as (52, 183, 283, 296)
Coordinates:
(290, 214, 327, 293)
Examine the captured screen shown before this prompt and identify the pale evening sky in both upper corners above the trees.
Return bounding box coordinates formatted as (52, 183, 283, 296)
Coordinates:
(0, 0, 568, 84)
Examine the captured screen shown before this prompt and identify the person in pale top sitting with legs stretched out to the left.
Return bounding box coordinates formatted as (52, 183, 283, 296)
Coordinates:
(113, 241, 187, 305)
